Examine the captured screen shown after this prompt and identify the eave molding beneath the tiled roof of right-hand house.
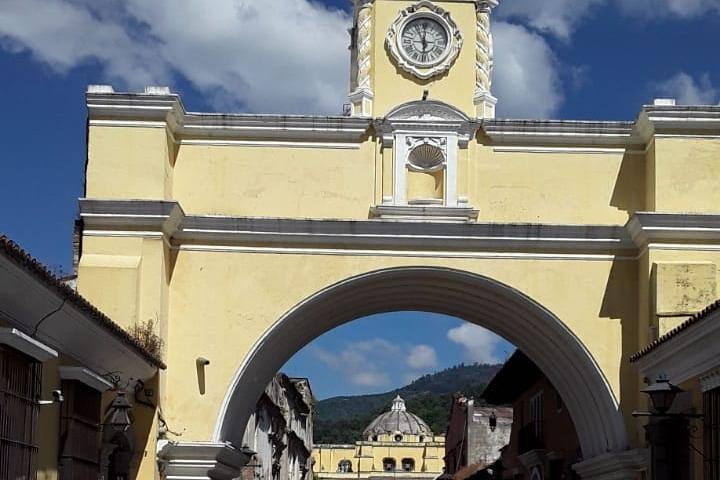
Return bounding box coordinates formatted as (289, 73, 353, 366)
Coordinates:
(635, 310, 720, 385)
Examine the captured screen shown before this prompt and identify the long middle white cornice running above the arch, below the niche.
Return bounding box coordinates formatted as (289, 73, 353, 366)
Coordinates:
(80, 199, 636, 256)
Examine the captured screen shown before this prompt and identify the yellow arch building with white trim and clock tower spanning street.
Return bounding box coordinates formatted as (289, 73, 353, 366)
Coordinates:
(78, 0, 720, 479)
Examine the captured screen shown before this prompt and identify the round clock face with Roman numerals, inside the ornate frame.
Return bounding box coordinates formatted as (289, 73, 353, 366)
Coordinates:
(400, 17, 448, 66)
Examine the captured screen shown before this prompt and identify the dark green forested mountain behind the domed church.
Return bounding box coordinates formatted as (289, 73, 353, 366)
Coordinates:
(315, 364, 502, 443)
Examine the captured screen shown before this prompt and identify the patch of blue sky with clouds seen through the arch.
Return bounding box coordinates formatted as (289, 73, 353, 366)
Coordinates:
(283, 312, 514, 399)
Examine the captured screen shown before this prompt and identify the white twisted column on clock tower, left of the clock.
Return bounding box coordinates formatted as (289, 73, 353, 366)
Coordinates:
(348, 0, 374, 117)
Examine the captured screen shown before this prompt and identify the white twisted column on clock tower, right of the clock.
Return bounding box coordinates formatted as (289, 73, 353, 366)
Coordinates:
(473, 0, 497, 118)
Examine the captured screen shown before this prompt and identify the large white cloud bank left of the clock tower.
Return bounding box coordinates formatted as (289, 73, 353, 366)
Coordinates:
(0, 0, 350, 113)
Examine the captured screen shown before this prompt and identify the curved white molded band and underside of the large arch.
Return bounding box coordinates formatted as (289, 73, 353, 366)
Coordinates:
(213, 267, 628, 462)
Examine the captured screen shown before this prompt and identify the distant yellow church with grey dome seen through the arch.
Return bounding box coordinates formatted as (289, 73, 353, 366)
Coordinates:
(313, 395, 445, 480)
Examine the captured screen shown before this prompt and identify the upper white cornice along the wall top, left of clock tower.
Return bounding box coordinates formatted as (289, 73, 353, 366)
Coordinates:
(86, 92, 370, 142)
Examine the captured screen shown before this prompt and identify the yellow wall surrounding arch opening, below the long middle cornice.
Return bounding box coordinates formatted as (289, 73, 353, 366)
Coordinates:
(153, 251, 636, 438)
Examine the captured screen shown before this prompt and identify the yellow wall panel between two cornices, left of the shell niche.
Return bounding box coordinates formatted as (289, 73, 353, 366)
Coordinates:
(173, 142, 375, 218)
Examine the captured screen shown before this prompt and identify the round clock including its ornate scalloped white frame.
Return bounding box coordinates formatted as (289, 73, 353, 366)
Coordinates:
(386, 0, 463, 79)
